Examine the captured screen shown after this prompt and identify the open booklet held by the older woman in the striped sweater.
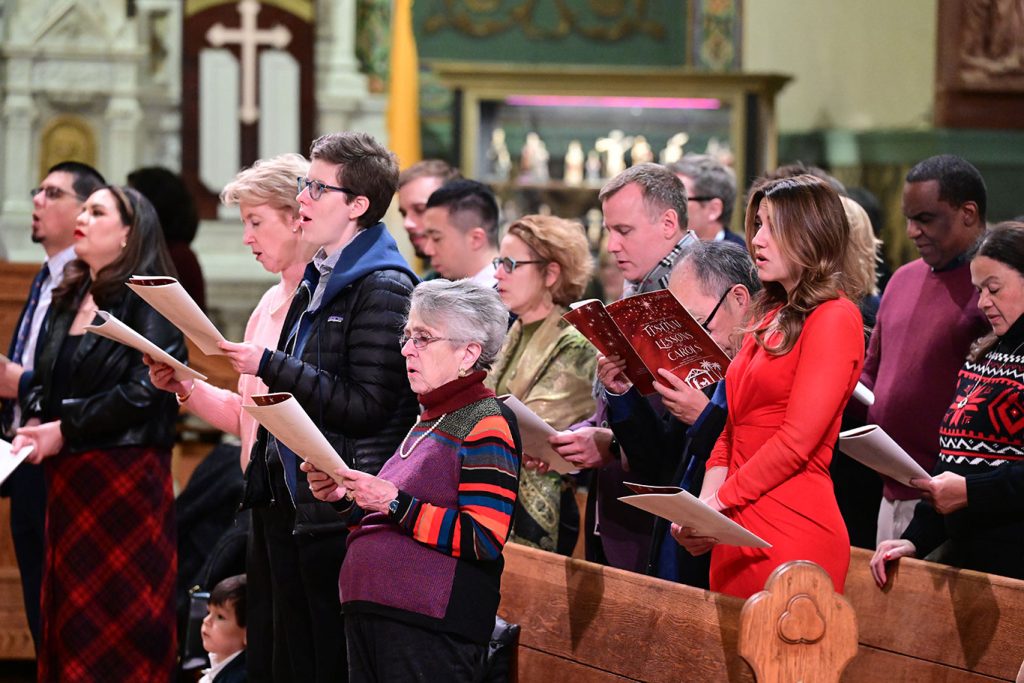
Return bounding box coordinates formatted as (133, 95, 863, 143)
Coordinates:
(242, 393, 348, 484)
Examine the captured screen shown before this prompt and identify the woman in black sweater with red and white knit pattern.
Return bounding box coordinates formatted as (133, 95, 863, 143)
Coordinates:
(871, 222, 1024, 586)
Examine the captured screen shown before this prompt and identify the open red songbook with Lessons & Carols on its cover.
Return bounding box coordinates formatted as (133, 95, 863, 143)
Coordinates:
(562, 290, 729, 396)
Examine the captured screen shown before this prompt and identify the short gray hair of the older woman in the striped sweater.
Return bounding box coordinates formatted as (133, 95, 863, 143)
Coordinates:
(409, 279, 509, 370)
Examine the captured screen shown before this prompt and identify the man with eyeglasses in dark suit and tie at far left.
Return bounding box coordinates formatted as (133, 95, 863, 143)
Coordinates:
(0, 162, 105, 645)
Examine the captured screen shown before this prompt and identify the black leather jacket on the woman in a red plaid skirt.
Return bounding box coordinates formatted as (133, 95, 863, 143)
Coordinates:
(23, 285, 188, 453)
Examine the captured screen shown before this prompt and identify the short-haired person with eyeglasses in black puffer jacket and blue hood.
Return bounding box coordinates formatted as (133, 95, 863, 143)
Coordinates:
(221, 132, 419, 682)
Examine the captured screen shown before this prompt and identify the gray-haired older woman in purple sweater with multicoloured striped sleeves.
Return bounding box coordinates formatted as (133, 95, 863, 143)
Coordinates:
(302, 280, 521, 683)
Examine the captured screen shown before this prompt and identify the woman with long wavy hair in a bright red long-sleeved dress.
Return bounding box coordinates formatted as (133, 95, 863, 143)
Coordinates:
(673, 175, 865, 598)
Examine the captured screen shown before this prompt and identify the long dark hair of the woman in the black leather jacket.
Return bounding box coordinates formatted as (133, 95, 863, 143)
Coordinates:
(53, 185, 177, 308)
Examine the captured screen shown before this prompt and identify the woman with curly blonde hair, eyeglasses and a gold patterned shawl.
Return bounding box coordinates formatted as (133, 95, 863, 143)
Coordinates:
(487, 215, 597, 553)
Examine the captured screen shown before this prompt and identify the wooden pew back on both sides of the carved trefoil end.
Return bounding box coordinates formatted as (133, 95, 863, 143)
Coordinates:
(499, 544, 1024, 683)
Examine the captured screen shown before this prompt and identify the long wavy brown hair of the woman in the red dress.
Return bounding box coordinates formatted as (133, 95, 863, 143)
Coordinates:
(745, 174, 864, 355)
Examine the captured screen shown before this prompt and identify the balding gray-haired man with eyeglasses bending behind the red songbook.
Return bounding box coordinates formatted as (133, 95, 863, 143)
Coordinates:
(598, 242, 761, 588)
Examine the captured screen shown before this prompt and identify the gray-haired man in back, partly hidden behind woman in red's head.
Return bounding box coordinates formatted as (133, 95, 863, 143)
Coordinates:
(669, 155, 746, 249)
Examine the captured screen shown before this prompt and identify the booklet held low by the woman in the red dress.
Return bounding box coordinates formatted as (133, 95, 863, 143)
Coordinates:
(618, 481, 771, 548)
